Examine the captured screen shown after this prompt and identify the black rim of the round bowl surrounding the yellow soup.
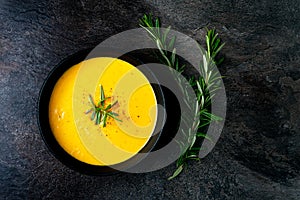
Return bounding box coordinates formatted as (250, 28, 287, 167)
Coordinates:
(38, 49, 173, 175)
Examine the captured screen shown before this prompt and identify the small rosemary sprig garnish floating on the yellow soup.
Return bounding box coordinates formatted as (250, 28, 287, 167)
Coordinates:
(85, 85, 122, 127)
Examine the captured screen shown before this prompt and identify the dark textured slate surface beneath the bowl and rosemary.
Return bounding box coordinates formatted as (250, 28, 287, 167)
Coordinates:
(0, 0, 300, 199)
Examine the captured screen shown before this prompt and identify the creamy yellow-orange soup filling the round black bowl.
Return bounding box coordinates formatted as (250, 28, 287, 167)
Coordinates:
(49, 57, 157, 165)
